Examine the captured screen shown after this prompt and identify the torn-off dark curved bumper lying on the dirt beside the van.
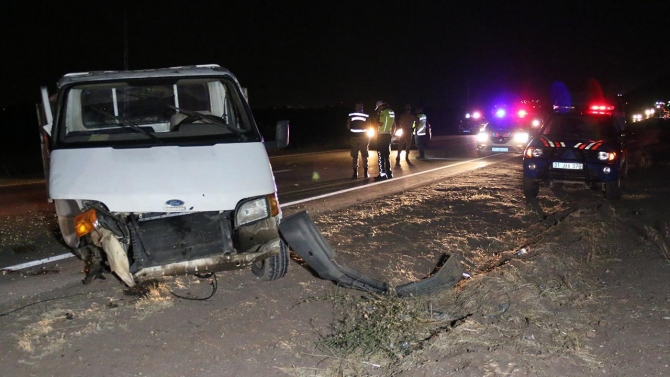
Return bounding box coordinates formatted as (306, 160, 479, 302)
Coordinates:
(279, 211, 464, 296)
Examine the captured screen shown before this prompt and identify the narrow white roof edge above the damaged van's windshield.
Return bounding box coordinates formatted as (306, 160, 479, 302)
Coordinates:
(58, 64, 235, 88)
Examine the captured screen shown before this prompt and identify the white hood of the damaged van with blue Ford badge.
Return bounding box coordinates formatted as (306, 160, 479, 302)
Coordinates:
(49, 142, 276, 212)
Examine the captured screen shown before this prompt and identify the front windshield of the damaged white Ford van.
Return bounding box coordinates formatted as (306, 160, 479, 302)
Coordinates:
(56, 77, 261, 147)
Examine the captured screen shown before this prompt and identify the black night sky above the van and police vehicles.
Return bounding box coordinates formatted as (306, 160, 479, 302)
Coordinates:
(0, 0, 670, 108)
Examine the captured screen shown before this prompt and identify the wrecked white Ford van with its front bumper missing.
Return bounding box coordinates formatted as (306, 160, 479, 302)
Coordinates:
(39, 65, 289, 286)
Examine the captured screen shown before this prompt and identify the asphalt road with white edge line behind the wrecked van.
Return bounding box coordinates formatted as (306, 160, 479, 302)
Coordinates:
(0, 136, 520, 269)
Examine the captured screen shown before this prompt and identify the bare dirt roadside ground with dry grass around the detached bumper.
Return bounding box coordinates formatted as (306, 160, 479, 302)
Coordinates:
(0, 158, 670, 376)
